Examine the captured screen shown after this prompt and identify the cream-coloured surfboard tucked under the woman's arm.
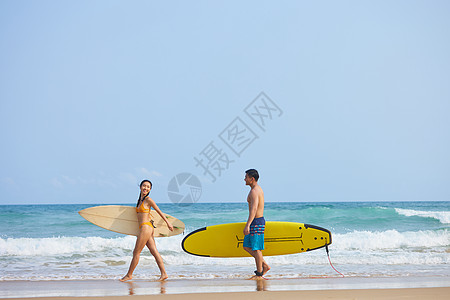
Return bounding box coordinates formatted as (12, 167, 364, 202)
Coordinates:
(78, 205, 184, 237)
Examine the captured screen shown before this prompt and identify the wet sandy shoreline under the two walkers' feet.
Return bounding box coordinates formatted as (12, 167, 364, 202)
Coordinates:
(0, 276, 450, 300)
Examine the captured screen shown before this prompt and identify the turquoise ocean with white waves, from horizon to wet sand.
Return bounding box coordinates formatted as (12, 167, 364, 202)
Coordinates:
(0, 201, 450, 281)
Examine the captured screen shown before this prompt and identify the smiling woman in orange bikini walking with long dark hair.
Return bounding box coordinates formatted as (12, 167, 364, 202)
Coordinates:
(120, 180, 173, 281)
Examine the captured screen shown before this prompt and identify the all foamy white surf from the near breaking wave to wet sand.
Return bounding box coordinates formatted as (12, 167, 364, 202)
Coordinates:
(0, 230, 450, 280)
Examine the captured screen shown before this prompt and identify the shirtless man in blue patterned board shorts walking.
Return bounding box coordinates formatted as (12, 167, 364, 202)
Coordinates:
(244, 169, 270, 279)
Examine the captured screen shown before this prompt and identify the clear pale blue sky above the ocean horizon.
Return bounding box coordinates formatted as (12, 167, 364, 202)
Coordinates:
(0, 0, 450, 204)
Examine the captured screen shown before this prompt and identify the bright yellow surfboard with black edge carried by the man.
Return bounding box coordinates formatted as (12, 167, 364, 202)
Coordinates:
(181, 222, 331, 257)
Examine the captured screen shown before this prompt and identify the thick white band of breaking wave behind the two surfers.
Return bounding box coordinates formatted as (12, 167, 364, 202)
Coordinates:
(0, 229, 450, 258)
